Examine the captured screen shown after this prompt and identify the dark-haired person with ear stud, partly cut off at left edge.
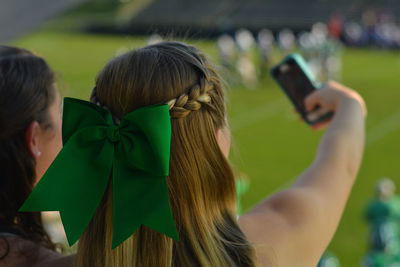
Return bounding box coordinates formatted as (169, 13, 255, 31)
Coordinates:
(0, 46, 71, 267)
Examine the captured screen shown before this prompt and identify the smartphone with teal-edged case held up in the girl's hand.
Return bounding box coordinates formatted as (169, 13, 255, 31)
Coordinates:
(271, 54, 333, 125)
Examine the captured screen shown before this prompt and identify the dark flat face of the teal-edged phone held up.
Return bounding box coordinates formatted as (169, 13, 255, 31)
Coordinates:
(274, 59, 316, 115)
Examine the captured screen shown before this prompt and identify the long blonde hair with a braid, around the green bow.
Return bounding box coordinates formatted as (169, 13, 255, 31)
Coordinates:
(77, 42, 255, 267)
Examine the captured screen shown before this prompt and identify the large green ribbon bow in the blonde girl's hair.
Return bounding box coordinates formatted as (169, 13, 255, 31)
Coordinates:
(20, 98, 178, 248)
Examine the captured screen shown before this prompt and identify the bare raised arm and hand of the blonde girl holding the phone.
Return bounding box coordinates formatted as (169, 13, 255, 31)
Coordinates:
(239, 82, 366, 267)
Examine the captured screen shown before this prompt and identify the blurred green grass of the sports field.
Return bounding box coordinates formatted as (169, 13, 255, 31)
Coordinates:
(15, 31, 400, 267)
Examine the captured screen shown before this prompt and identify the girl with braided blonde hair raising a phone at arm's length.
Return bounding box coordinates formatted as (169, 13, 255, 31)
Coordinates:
(21, 42, 365, 267)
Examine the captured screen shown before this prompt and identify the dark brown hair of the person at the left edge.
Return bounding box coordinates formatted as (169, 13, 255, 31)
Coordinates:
(0, 46, 56, 259)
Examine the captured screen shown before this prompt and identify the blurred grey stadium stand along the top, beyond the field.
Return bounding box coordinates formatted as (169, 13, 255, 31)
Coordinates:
(129, 0, 400, 35)
